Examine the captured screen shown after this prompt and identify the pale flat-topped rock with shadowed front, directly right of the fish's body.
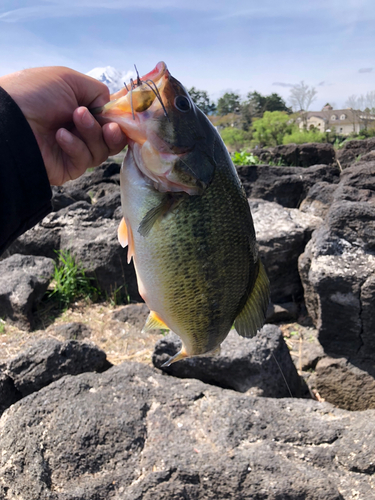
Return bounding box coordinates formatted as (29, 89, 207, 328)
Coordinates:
(249, 200, 322, 303)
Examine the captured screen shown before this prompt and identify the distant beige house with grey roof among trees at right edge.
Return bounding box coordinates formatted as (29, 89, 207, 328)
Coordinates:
(297, 104, 375, 135)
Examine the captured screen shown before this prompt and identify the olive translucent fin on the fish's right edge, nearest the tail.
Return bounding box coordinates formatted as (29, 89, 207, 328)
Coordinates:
(234, 260, 270, 337)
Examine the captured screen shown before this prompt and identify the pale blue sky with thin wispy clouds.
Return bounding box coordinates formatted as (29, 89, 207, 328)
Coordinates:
(0, 0, 375, 110)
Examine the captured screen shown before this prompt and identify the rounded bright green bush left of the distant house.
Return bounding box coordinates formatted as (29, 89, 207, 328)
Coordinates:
(252, 111, 295, 147)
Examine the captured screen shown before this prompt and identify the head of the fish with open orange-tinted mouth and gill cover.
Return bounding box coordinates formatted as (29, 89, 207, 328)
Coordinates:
(94, 62, 217, 195)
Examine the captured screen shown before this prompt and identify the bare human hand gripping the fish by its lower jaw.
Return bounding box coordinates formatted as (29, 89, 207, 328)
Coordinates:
(0, 66, 126, 186)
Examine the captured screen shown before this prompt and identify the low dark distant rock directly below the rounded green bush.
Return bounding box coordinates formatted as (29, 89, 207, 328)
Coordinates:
(253, 143, 336, 167)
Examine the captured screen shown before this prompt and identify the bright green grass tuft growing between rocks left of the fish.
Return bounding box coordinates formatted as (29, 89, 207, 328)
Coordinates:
(49, 250, 99, 308)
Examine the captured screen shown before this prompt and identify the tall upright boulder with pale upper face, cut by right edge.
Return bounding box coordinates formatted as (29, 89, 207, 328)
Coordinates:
(299, 202, 375, 361)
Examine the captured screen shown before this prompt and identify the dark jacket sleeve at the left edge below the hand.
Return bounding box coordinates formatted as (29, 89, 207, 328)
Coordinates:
(0, 87, 52, 255)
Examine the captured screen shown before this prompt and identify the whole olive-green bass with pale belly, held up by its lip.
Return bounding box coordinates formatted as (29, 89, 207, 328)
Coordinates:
(93, 62, 270, 366)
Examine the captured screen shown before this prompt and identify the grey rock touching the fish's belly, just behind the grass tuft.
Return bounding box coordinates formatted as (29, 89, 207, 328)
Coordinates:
(8, 198, 142, 301)
